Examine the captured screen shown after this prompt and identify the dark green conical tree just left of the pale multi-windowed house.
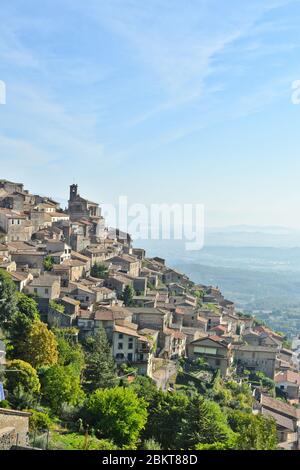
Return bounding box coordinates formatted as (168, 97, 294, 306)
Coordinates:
(85, 328, 117, 390)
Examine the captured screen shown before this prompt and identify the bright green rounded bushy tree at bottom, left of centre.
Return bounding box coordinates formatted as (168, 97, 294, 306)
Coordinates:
(87, 387, 147, 448)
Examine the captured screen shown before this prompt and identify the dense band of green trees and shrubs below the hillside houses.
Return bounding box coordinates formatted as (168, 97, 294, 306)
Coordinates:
(0, 272, 276, 450)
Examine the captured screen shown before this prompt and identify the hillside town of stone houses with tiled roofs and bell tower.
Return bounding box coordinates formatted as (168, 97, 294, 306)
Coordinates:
(0, 180, 300, 450)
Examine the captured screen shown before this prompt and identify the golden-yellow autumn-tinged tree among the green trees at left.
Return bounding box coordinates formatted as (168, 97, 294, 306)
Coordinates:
(24, 321, 58, 368)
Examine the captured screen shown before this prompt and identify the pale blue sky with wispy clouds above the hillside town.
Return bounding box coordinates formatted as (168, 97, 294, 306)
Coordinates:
(0, 0, 300, 228)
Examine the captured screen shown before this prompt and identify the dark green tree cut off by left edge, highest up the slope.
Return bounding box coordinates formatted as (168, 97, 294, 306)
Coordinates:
(0, 269, 17, 330)
